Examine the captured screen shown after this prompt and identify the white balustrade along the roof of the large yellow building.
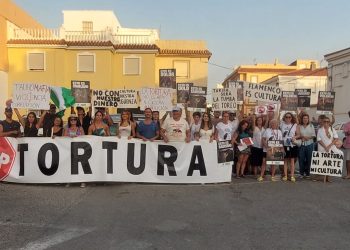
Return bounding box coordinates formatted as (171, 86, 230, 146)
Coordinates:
(8, 28, 158, 44)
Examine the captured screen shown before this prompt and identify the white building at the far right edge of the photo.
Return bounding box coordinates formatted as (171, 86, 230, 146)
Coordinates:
(324, 48, 350, 121)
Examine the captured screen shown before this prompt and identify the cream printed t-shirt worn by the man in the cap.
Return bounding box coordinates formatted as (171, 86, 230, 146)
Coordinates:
(162, 118, 190, 141)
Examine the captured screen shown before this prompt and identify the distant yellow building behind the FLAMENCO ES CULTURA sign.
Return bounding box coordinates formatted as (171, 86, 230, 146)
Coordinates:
(222, 59, 319, 114)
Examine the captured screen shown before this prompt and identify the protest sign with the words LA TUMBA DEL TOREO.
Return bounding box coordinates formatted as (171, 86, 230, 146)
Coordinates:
(211, 88, 237, 111)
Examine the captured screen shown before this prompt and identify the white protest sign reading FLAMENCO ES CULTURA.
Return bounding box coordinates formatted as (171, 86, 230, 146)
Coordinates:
(244, 82, 282, 103)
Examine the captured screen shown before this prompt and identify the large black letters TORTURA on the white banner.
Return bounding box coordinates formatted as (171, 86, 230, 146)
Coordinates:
(18, 141, 207, 176)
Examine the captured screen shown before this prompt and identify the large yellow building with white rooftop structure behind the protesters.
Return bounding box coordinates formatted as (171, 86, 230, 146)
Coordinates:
(3, 6, 211, 117)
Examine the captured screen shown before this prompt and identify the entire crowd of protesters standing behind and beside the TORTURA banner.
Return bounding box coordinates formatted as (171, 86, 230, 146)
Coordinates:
(0, 101, 350, 184)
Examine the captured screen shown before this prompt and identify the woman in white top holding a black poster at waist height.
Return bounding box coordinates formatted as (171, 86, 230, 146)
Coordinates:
(258, 119, 282, 181)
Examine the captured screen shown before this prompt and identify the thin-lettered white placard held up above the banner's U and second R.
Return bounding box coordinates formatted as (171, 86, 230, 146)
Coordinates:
(140, 88, 174, 111)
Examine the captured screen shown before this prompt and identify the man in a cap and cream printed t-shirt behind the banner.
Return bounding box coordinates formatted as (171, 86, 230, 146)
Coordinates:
(161, 106, 191, 142)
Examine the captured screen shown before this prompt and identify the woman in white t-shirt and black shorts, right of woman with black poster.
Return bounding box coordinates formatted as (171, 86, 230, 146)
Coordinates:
(280, 112, 298, 182)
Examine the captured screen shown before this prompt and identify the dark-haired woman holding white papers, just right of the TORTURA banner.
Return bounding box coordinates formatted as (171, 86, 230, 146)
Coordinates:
(232, 120, 251, 178)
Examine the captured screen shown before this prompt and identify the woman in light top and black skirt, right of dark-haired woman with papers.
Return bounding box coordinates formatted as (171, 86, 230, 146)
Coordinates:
(250, 116, 265, 176)
